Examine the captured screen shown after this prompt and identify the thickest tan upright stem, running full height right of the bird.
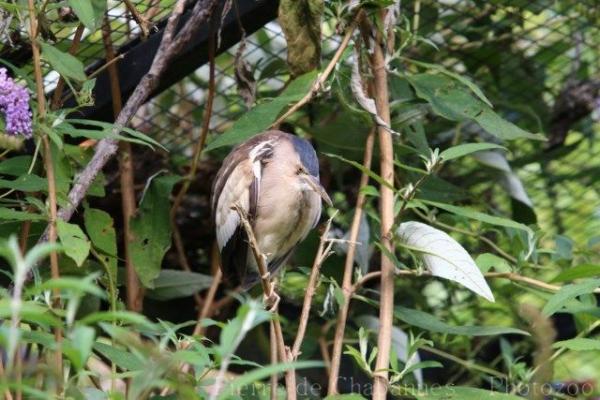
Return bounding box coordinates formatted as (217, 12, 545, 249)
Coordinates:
(363, 10, 395, 400)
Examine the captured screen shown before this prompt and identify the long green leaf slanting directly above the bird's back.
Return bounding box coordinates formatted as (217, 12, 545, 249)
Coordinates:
(205, 71, 317, 151)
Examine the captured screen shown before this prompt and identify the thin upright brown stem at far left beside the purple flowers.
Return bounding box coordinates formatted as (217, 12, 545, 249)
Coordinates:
(27, 0, 62, 390)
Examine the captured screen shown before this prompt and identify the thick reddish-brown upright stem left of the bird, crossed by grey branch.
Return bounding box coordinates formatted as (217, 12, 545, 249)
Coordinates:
(102, 17, 143, 312)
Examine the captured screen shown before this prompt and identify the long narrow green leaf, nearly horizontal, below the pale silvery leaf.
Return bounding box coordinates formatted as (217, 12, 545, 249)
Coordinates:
(394, 306, 529, 336)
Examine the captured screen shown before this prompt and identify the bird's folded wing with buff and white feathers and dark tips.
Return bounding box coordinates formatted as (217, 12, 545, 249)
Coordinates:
(212, 136, 273, 284)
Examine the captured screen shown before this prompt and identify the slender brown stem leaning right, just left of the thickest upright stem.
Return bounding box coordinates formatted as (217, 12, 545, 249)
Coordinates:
(328, 129, 375, 395)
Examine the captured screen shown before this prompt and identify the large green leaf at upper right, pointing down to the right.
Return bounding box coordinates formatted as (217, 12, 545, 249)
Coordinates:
(406, 73, 543, 140)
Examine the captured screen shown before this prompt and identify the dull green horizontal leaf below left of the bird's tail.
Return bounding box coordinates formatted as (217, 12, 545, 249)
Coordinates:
(146, 269, 212, 301)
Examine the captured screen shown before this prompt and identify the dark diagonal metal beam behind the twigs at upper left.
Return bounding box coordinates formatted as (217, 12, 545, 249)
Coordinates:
(65, 0, 279, 122)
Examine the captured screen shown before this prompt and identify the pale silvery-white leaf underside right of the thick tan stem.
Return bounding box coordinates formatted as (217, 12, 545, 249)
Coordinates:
(397, 221, 494, 302)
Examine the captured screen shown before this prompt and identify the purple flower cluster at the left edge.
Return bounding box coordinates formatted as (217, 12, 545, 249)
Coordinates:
(0, 68, 31, 138)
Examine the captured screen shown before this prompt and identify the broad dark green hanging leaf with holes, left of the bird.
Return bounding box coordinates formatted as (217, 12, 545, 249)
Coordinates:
(130, 175, 181, 288)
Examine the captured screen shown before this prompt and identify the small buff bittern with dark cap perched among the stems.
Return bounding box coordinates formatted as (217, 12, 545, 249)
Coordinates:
(212, 130, 331, 289)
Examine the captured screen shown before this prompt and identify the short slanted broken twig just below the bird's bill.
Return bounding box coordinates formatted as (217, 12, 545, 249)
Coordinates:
(290, 213, 338, 361)
